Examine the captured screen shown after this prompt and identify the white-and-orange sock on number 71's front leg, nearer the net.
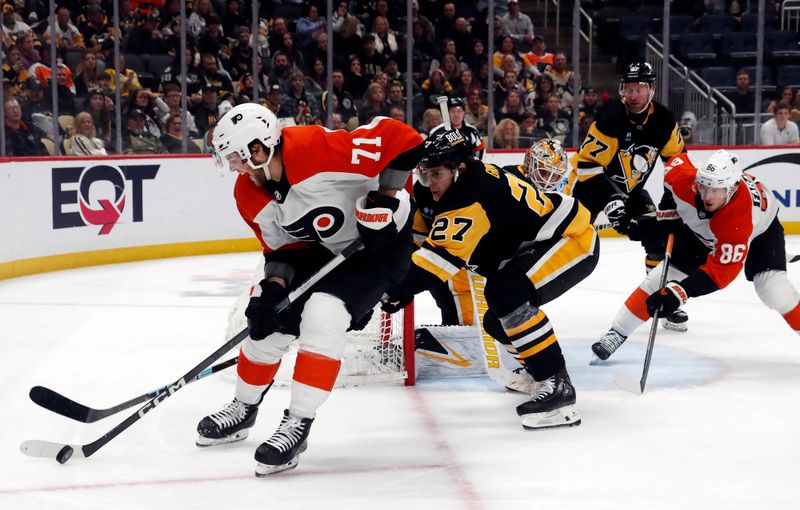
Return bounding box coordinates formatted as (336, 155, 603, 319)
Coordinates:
(289, 292, 351, 418)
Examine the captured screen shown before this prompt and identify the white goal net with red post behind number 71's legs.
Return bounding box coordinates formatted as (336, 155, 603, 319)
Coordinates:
(226, 263, 415, 387)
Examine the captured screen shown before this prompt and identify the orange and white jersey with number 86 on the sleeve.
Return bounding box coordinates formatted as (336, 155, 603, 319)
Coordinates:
(664, 154, 778, 289)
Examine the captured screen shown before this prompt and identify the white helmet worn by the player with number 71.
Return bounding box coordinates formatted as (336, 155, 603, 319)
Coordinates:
(211, 103, 281, 170)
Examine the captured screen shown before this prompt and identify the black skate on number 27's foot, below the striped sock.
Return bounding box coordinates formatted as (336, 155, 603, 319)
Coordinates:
(517, 367, 581, 430)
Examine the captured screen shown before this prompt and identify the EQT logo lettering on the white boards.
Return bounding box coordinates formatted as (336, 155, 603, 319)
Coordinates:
(53, 165, 159, 235)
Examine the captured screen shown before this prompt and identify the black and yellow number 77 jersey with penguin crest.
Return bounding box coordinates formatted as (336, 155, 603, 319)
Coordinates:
(564, 101, 686, 215)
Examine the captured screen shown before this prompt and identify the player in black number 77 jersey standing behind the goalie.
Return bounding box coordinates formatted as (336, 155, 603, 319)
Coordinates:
(565, 62, 688, 334)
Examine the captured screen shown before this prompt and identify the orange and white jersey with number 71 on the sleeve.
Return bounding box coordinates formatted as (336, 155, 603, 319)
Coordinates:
(234, 117, 422, 253)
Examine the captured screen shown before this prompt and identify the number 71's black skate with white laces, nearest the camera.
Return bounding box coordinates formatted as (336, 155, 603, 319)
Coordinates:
(255, 409, 314, 477)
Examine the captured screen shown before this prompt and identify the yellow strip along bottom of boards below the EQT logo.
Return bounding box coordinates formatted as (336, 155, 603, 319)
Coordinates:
(0, 238, 261, 280)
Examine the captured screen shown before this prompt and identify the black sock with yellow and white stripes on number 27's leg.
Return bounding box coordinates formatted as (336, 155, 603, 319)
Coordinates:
(500, 303, 564, 381)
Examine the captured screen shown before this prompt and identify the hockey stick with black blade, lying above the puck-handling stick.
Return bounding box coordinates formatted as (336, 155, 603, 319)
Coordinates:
(29, 356, 239, 423)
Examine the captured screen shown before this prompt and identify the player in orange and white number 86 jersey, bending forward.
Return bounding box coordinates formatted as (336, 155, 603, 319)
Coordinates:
(592, 150, 800, 360)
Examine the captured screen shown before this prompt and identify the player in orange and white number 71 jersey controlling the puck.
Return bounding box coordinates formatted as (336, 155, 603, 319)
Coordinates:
(197, 103, 422, 476)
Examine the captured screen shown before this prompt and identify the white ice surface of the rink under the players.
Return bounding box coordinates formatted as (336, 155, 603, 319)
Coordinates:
(0, 237, 800, 510)
